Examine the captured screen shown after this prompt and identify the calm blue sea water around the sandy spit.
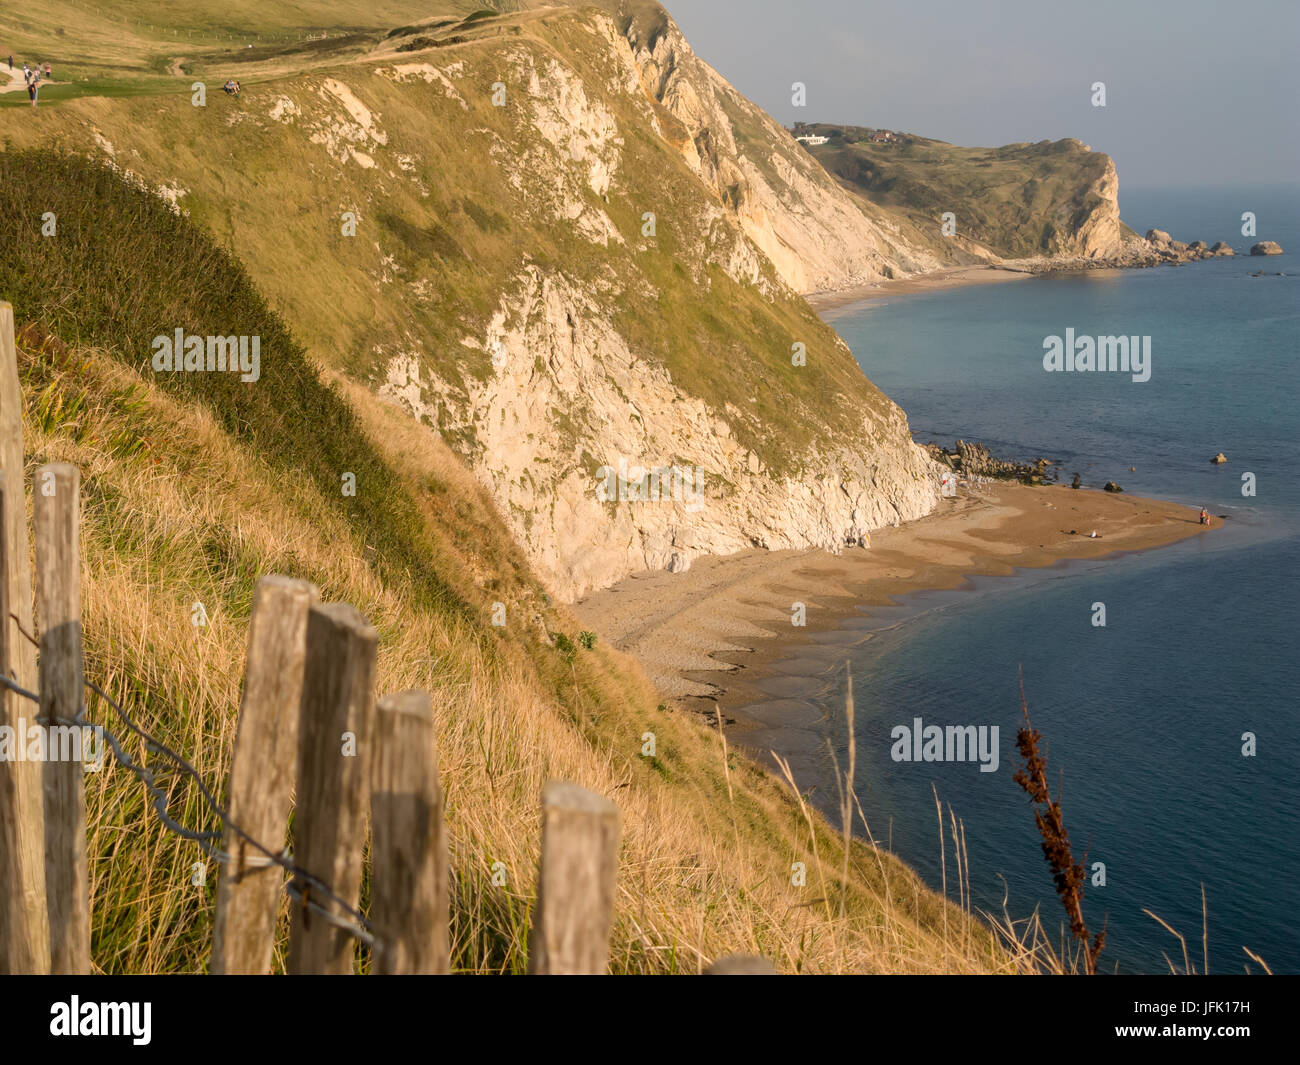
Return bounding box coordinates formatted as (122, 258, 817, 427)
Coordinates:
(820, 189, 1300, 973)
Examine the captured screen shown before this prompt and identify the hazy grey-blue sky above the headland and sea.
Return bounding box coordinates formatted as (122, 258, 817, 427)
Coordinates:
(664, 0, 1300, 187)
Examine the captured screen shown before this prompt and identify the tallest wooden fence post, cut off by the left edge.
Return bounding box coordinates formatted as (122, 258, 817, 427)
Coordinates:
(0, 302, 49, 974)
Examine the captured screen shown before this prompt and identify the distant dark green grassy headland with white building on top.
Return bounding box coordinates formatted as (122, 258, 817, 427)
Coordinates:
(798, 124, 1110, 257)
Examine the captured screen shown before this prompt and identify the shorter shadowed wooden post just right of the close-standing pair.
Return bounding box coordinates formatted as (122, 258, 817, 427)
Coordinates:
(371, 692, 451, 975)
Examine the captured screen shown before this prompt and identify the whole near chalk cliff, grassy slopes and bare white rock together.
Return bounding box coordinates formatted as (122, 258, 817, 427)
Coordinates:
(20, 0, 1159, 599)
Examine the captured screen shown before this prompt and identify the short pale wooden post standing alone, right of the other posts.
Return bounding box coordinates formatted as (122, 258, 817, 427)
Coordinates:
(528, 780, 619, 975)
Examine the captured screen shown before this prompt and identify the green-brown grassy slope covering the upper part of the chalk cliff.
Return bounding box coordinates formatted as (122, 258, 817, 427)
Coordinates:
(0, 12, 889, 483)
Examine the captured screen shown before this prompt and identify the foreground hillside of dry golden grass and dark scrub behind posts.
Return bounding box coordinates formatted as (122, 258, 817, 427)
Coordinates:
(0, 148, 1014, 973)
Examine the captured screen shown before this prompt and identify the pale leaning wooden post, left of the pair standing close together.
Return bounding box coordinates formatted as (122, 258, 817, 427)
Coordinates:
(209, 576, 316, 974)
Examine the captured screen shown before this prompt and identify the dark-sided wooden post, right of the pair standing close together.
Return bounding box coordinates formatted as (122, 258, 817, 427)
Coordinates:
(289, 603, 378, 975)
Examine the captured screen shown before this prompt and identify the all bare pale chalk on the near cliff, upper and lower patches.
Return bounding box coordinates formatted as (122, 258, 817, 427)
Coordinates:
(369, 13, 937, 599)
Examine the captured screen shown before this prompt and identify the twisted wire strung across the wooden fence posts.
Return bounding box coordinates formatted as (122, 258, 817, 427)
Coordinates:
(0, 614, 376, 948)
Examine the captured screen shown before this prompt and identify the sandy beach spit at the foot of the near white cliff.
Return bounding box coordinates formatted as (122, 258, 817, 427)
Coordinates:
(573, 482, 1222, 728)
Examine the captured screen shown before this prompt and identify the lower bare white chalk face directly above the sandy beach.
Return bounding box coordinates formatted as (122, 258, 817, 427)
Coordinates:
(381, 268, 937, 601)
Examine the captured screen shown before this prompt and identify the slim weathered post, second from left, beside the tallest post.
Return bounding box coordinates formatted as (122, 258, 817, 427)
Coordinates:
(34, 463, 90, 975)
